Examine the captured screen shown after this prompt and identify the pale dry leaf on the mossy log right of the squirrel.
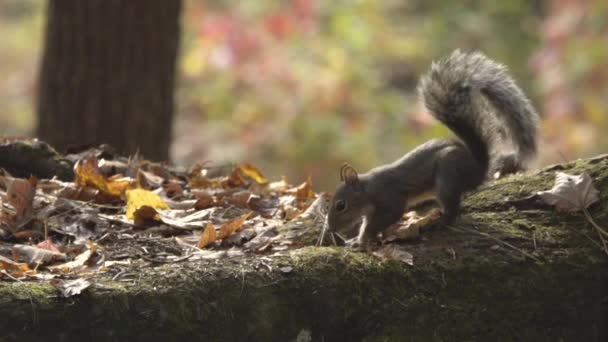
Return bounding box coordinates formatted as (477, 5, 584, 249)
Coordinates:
(537, 172, 599, 211)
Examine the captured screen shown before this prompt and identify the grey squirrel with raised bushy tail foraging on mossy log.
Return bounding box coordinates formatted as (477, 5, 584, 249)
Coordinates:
(321, 50, 539, 247)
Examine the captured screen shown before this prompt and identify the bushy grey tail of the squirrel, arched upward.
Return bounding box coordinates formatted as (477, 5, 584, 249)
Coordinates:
(419, 50, 539, 170)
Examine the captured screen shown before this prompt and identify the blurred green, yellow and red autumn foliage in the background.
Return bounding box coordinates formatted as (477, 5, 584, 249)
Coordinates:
(0, 0, 608, 190)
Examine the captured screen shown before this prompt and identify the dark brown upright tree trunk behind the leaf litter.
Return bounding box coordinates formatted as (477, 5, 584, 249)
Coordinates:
(37, 0, 181, 160)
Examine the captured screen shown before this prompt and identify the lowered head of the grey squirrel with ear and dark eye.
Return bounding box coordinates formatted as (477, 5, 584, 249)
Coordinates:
(327, 164, 371, 232)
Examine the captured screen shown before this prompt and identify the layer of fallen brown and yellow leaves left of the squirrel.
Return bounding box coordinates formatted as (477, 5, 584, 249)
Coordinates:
(0, 149, 432, 297)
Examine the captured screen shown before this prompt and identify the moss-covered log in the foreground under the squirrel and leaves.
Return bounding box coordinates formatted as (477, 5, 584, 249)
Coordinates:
(0, 156, 608, 341)
